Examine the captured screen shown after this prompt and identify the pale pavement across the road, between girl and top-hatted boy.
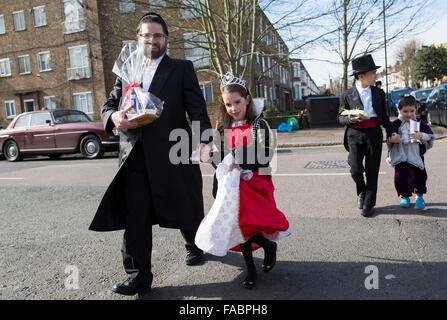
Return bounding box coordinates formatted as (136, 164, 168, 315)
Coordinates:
(277, 118, 447, 149)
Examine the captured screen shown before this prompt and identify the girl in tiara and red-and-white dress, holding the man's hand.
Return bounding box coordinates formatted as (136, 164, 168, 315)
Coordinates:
(199, 74, 290, 289)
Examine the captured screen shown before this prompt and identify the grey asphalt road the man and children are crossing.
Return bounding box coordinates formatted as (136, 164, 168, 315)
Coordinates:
(0, 139, 447, 300)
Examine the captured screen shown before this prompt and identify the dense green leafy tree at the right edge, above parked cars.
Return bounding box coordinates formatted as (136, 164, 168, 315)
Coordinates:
(413, 45, 447, 82)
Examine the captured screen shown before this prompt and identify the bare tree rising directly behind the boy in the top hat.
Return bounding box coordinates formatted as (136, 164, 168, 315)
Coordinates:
(324, 0, 431, 90)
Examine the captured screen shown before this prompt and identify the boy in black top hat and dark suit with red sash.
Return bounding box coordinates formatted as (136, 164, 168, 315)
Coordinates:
(338, 54, 398, 217)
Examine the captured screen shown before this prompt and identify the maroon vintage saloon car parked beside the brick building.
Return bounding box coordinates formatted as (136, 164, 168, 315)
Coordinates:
(0, 109, 119, 161)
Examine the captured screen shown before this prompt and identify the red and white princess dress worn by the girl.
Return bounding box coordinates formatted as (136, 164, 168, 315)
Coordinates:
(195, 118, 290, 256)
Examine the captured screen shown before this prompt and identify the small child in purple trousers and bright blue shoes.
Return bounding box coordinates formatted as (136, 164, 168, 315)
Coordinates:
(387, 96, 435, 209)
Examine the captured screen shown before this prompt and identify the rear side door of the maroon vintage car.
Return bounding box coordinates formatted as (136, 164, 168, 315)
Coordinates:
(25, 112, 56, 152)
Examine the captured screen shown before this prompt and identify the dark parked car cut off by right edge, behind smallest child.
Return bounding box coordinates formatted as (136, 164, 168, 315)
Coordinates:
(425, 83, 447, 126)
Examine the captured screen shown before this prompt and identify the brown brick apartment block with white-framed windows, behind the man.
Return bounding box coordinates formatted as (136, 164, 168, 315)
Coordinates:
(0, 0, 298, 127)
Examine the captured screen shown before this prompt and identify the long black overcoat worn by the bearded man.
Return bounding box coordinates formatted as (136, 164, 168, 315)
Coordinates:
(89, 55, 211, 231)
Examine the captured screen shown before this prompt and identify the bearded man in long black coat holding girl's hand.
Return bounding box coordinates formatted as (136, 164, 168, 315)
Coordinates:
(89, 13, 211, 295)
